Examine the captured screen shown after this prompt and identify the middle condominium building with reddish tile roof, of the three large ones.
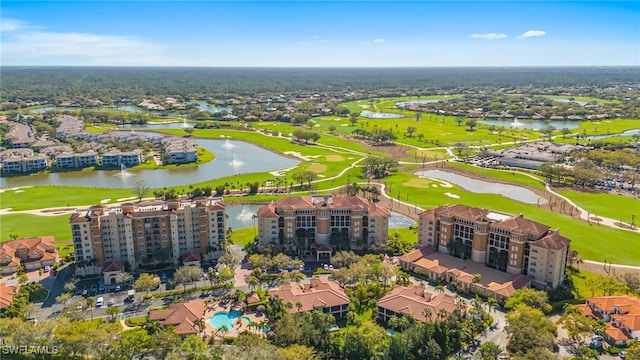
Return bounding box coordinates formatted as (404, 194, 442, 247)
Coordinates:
(257, 195, 389, 261)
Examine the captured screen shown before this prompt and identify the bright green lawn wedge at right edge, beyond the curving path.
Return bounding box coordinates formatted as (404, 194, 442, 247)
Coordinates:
(557, 190, 640, 224)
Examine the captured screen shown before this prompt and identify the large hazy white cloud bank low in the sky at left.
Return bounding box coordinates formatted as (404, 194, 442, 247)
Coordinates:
(1, 31, 175, 65)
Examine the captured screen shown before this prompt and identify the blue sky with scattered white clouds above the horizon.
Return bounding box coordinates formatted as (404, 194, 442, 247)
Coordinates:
(0, 1, 640, 67)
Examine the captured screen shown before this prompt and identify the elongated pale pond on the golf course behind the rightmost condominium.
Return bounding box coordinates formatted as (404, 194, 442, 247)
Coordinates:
(416, 170, 547, 204)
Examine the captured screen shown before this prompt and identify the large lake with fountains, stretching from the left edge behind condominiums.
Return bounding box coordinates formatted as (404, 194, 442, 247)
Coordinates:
(0, 132, 299, 188)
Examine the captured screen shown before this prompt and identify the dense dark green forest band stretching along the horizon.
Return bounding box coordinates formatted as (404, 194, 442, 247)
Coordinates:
(0, 67, 640, 102)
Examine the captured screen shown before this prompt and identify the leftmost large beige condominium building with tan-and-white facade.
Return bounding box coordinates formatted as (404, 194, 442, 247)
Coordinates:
(69, 197, 226, 272)
